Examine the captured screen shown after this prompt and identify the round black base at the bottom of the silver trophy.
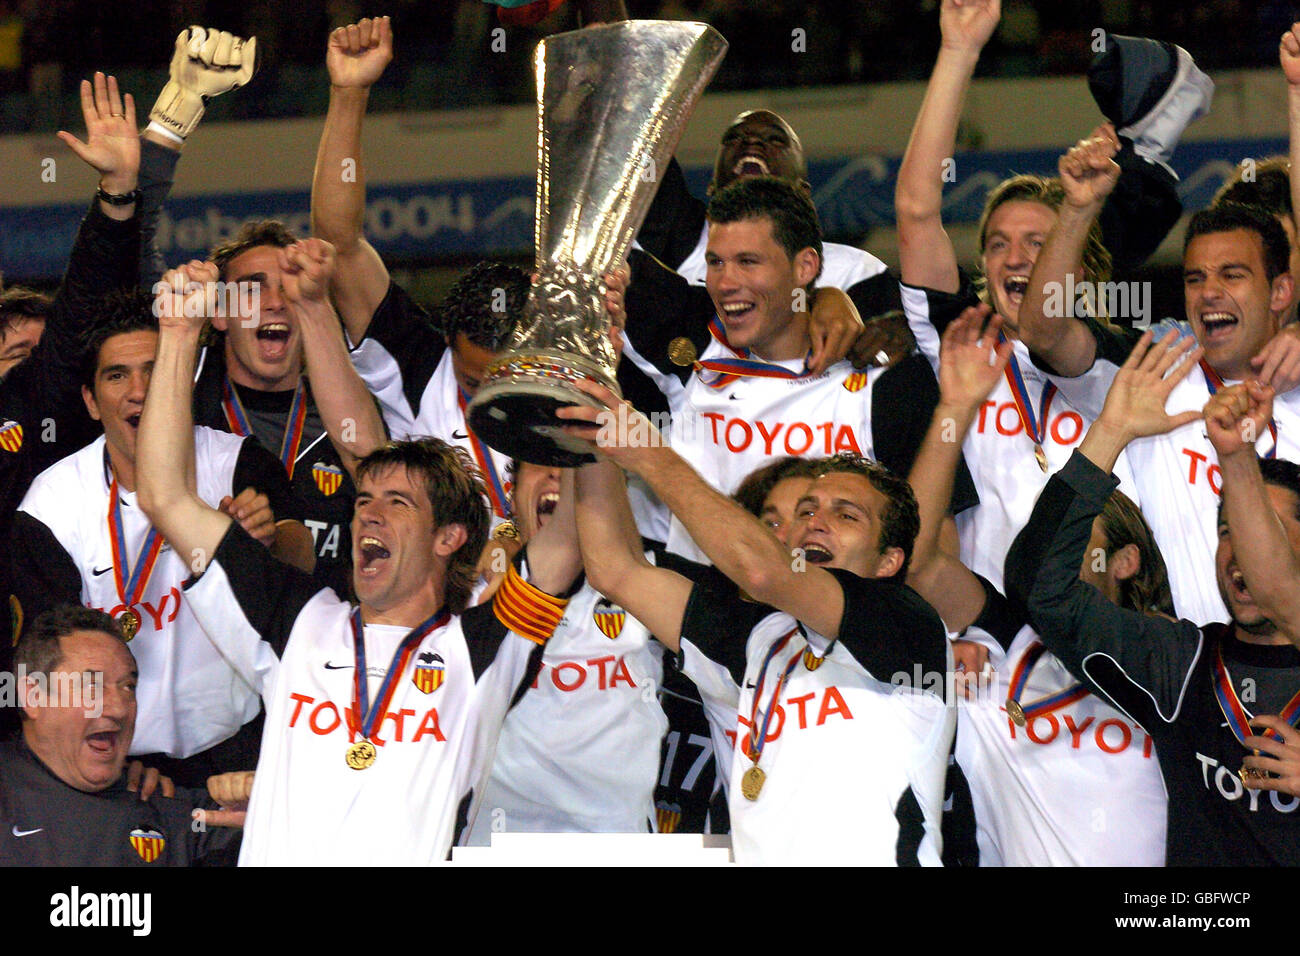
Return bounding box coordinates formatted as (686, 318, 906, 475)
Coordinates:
(465, 377, 613, 468)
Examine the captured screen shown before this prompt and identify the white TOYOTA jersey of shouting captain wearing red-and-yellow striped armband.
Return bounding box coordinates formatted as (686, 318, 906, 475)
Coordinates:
(178, 528, 553, 866)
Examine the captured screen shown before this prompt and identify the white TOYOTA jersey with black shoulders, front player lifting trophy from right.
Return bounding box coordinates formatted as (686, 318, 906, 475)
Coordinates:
(683, 571, 957, 866)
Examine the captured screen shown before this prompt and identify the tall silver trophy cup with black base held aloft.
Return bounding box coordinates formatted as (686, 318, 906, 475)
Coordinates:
(467, 20, 727, 467)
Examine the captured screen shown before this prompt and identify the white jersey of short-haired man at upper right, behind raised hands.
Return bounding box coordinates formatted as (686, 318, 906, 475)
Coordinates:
(1056, 338, 1300, 626)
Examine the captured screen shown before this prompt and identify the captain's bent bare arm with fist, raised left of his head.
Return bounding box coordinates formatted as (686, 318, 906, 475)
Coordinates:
(135, 263, 231, 574)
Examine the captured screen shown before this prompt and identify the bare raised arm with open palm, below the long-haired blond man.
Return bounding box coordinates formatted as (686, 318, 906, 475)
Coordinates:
(907, 306, 1013, 631)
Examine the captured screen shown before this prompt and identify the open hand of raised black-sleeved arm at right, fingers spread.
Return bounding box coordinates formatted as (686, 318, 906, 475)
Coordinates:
(1097, 329, 1203, 441)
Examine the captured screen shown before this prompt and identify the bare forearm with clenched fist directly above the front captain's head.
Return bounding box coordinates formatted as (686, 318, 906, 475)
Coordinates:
(280, 239, 386, 473)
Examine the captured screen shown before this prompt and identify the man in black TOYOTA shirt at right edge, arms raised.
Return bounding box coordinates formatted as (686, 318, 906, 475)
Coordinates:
(1006, 332, 1300, 866)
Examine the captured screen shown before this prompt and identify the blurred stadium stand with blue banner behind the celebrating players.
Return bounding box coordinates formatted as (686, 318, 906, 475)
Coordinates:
(0, 0, 1296, 319)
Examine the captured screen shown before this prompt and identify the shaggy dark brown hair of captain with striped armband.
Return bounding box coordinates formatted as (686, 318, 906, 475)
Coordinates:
(356, 438, 489, 614)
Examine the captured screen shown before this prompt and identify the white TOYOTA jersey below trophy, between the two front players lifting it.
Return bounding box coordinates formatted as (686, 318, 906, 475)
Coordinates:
(468, 572, 668, 845)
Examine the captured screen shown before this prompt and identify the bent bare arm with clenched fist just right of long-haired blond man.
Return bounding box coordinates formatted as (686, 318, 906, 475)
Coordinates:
(1018, 124, 1119, 377)
